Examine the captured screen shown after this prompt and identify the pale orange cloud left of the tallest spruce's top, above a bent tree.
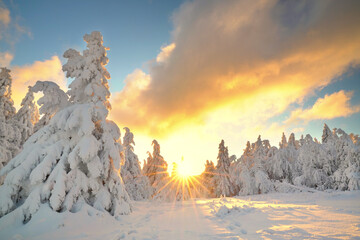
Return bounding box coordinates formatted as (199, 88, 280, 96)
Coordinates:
(11, 56, 66, 109)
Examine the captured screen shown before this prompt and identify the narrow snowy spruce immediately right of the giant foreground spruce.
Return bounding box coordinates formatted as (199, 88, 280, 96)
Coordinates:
(121, 127, 152, 201)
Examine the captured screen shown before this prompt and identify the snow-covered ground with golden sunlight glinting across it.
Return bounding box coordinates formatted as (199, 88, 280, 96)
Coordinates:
(0, 191, 360, 240)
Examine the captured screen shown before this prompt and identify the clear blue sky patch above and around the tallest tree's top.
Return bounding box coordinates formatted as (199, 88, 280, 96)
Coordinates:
(0, 0, 182, 91)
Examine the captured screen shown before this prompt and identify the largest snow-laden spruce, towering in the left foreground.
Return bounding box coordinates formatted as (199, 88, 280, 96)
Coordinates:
(0, 32, 131, 220)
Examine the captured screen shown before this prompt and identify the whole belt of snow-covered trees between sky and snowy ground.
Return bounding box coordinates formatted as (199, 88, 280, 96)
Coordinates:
(0, 32, 360, 222)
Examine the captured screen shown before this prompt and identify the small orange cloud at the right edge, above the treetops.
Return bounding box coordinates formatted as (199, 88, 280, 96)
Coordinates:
(284, 90, 360, 124)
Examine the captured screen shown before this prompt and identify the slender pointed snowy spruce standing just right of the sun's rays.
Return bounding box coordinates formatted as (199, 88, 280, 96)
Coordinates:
(213, 140, 235, 197)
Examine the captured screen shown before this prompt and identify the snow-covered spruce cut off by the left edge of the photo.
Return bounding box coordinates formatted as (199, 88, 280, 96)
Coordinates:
(0, 68, 21, 184)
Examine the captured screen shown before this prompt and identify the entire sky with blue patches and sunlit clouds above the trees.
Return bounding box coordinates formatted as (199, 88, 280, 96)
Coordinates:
(0, 0, 360, 174)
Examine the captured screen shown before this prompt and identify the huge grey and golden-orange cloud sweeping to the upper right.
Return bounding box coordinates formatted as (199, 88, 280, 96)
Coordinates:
(112, 0, 360, 137)
